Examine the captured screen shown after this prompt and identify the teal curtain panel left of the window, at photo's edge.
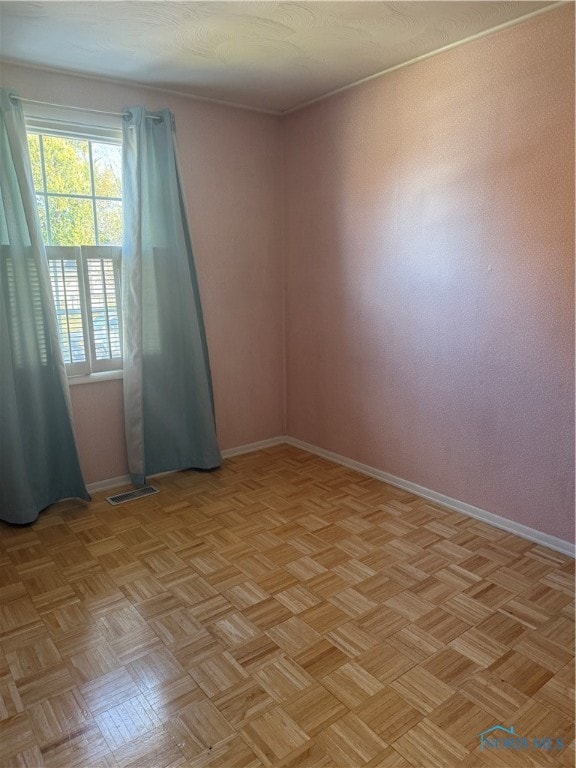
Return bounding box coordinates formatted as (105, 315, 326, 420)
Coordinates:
(0, 88, 90, 523)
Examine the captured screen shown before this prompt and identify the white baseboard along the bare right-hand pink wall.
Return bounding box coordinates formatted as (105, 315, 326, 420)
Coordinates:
(285, 437, 576, 557)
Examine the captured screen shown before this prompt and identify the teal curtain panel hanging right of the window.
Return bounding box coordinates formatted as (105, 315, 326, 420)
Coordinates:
(122, 107, 221, 485)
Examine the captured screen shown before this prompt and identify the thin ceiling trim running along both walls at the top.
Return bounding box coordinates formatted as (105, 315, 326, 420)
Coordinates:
(0, 0, 574, 117)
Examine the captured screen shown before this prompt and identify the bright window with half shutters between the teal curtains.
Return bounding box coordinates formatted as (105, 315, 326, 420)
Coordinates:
(27, 119, 122, 375)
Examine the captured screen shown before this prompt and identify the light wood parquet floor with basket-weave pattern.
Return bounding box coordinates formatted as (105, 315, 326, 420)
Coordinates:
(0, 446, 575, 768)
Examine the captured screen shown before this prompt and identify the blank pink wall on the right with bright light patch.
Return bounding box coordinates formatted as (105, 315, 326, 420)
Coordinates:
(283, 7, 574, 540)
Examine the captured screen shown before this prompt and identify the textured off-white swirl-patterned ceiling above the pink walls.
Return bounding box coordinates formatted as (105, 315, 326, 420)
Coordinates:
(0, 0, 556, 113)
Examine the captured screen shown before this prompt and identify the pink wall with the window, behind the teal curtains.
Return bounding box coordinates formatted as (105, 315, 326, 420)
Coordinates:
(2, 64, 285, 483)
